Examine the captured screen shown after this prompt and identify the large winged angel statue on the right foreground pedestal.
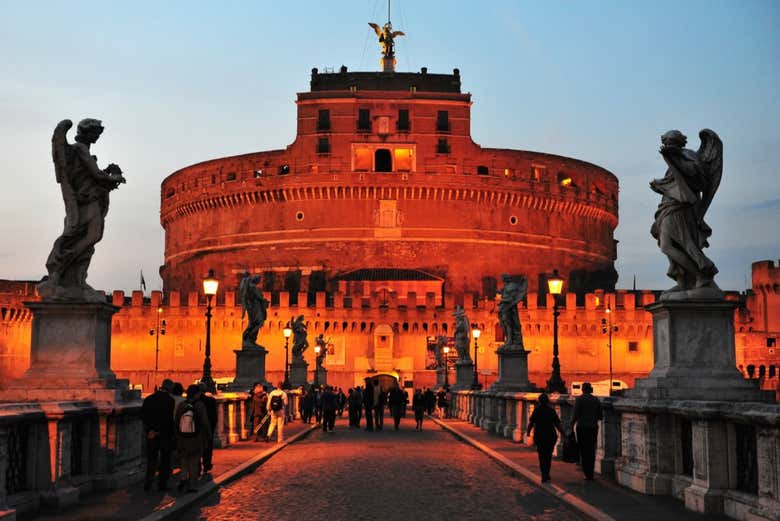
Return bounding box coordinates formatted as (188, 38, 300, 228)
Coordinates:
(650, 129, 723, 299)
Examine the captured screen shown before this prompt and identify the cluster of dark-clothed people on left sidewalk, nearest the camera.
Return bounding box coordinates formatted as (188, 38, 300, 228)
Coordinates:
(141, 379, 217, 492)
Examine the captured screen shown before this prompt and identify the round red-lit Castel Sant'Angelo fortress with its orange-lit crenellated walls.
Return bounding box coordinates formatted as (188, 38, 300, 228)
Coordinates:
(0, 21, 780, 389)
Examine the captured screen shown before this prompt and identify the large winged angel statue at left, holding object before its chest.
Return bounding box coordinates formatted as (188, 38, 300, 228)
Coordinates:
(38, 119, 125, 302)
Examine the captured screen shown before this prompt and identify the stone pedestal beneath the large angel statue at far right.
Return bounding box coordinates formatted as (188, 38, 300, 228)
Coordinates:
(627, 300, 764, 401)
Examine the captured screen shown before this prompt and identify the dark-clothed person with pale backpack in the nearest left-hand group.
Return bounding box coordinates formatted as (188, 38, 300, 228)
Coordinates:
(174, 384, 211, 492)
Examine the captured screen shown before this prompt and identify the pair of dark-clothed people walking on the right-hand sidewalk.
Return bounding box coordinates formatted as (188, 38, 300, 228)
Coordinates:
(527, 382, 602, 483)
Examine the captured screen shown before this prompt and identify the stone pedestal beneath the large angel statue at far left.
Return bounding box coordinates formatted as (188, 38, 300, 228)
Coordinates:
(1, 302, 140, 402)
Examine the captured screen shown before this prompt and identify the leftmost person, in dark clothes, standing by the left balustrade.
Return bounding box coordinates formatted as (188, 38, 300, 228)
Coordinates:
(141, 378, 175, 490)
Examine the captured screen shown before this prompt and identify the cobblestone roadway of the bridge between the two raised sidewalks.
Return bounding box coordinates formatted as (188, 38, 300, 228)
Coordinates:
(177, 417, 581, 521)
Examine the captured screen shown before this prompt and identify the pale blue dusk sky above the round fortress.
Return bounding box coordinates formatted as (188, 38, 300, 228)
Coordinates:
(0, 0, 780, 291)
